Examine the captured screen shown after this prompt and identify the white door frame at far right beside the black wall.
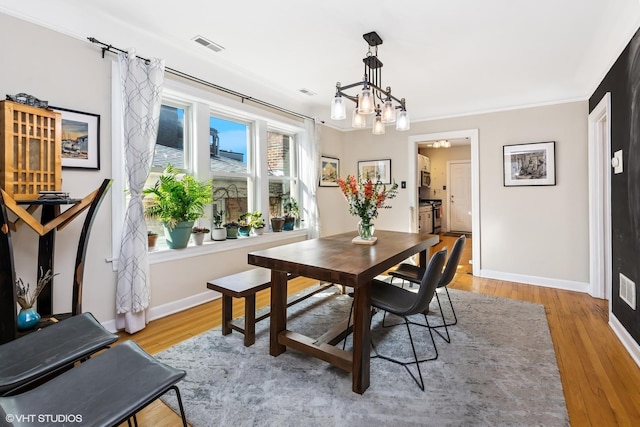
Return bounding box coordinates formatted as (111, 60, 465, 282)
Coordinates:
(589, 92, 612, 302)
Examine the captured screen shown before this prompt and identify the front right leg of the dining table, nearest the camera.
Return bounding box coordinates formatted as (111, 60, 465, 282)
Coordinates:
(351, 282, 371, 394)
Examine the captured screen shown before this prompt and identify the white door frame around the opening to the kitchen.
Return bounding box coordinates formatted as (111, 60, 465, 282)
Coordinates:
(407, 128, 482, 277)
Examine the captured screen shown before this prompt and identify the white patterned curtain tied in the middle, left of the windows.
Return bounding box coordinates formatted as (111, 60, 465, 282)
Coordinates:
(114, 51, 164, 334)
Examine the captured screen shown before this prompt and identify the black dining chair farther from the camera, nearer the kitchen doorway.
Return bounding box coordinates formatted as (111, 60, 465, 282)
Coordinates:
(389, 234, 467, 343)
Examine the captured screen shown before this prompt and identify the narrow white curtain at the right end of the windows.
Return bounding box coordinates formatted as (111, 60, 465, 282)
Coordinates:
(300, 119, 320, 239)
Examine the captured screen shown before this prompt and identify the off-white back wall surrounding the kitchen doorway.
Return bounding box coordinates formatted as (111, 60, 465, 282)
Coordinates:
(341, 101, 589, 290)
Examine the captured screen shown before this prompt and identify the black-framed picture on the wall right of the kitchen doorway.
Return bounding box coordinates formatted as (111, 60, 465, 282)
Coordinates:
(502, 141, 556, 187)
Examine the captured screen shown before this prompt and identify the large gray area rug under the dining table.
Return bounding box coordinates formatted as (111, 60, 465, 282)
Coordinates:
(156, 290, 569, 427)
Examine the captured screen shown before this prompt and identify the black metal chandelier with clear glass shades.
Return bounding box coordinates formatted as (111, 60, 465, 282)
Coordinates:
(331, 31, 410, 135)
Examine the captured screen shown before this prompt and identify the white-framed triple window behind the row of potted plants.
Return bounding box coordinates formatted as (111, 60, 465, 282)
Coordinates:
(136, 89, 301, 251)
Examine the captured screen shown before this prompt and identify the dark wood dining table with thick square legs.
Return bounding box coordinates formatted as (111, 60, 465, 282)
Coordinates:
(248, 230, 439, 394)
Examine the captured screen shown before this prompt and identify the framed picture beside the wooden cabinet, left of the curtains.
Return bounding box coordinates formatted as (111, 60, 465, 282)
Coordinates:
(51, 107, 100, 170)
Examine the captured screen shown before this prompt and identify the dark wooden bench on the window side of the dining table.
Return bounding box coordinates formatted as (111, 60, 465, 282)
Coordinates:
(207, 268, 333, 347)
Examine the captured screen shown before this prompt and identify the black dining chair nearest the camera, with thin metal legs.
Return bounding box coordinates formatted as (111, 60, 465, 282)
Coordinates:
(371, 248, 447, 391)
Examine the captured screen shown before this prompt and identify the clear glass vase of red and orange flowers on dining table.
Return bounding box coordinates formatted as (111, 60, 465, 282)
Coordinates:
(338, 175, 398, 240)
